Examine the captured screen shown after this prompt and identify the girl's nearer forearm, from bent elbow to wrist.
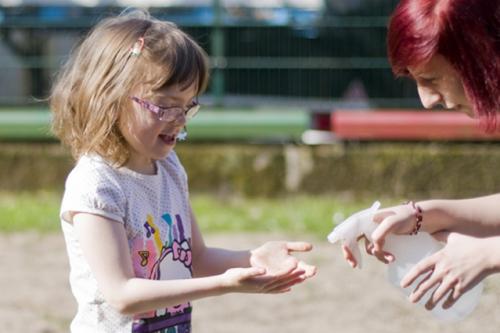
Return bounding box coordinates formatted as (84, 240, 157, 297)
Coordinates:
(113, 275, 230, 315)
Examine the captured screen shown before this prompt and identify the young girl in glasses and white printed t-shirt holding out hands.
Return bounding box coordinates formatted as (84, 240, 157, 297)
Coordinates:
(51, 12, 315, 333)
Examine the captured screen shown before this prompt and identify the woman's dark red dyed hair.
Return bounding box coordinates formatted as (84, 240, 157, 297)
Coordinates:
(387, 0, 500, 130)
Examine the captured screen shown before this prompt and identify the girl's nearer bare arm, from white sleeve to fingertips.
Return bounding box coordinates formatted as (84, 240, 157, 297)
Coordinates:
(73, 213, 306, 314)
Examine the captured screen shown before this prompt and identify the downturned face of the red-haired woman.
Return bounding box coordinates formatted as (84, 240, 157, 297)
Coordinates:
(408, 54, 475, 117)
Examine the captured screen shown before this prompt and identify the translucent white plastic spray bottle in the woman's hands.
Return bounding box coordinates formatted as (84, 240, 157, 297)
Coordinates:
(328, 201, 483, 321)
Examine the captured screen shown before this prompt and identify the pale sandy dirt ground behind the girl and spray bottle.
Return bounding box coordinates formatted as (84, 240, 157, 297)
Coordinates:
(0, 233, 500, 333)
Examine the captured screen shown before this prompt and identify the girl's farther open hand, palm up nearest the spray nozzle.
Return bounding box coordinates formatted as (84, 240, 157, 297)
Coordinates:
(250, 241, 316, 279)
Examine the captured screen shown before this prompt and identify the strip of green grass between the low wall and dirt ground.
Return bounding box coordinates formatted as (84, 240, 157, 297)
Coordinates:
(0, 192, 398, 237)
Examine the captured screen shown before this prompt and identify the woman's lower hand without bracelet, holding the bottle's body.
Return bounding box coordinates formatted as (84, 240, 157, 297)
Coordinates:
(401, 232, 500, 310)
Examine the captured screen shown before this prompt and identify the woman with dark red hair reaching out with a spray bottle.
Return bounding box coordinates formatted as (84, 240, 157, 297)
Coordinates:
(344, 0, 500, 310)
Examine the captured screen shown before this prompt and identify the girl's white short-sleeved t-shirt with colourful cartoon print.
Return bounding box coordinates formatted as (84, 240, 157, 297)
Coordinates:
(60, 152, 192, 333)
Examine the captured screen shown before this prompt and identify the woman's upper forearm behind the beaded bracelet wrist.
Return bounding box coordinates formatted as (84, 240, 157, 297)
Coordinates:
(418, 194, 500, 236)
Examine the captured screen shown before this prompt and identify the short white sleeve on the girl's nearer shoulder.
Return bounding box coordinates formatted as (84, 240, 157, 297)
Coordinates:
(61, 161, 126, 223)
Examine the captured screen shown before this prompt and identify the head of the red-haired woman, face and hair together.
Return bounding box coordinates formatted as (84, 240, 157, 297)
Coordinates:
(387, 0, 500, 131)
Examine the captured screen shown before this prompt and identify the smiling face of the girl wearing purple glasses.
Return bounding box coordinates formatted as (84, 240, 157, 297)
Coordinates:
(120, 85, 197, 174)
